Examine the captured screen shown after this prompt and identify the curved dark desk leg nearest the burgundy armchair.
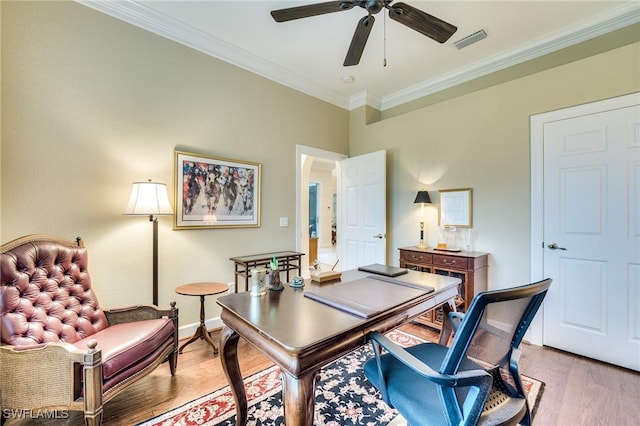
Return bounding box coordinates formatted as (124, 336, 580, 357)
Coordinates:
(220, 325, 247, 426)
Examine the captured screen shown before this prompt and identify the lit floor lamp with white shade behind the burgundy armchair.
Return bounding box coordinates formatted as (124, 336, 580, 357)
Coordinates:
(124, 179, 173, 305)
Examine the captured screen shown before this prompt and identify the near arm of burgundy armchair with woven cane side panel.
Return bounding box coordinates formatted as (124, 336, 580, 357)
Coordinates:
(0, 340, 102, 410)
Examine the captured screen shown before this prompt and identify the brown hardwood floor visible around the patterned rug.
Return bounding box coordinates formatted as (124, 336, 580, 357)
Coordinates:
(2, 324, 640, 426)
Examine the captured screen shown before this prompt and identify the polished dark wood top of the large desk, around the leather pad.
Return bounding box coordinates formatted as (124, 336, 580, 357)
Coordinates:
(217, 270, 461, 353)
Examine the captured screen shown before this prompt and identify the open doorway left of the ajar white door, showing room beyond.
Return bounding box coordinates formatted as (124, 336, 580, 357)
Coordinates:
(296, 145, 347, 277)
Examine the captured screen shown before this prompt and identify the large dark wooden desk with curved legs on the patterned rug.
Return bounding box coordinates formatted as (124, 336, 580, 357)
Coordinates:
(217, 270, 460, 426)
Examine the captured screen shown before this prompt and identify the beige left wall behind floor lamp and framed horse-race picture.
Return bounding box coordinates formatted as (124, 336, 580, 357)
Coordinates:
(1, 1, 349, 332)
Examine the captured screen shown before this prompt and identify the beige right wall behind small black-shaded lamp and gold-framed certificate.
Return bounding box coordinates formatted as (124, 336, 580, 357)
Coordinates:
(349, 43, 640, 287)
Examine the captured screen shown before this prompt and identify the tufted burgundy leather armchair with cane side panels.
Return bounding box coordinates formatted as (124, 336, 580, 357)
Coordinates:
(0, 235, 178, 425)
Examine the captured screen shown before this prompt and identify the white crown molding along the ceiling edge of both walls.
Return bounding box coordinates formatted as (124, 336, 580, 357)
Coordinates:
(75, 0, 640, 111)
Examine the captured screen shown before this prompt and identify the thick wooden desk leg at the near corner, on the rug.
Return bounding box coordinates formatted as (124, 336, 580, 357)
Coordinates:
(282, 371, 317, 426)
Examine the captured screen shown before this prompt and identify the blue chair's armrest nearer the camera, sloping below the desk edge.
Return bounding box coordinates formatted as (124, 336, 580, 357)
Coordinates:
(370, 331, 492, 386)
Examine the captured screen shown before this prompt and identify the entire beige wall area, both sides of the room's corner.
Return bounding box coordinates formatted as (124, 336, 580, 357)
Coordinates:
(5, 1, 640, 332)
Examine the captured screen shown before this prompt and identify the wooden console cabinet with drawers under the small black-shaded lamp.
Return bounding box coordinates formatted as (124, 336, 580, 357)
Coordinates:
(398, 246, 489, 330)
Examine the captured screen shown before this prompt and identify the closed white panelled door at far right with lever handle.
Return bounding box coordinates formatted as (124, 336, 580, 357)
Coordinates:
(543, 101, 640, 370)
